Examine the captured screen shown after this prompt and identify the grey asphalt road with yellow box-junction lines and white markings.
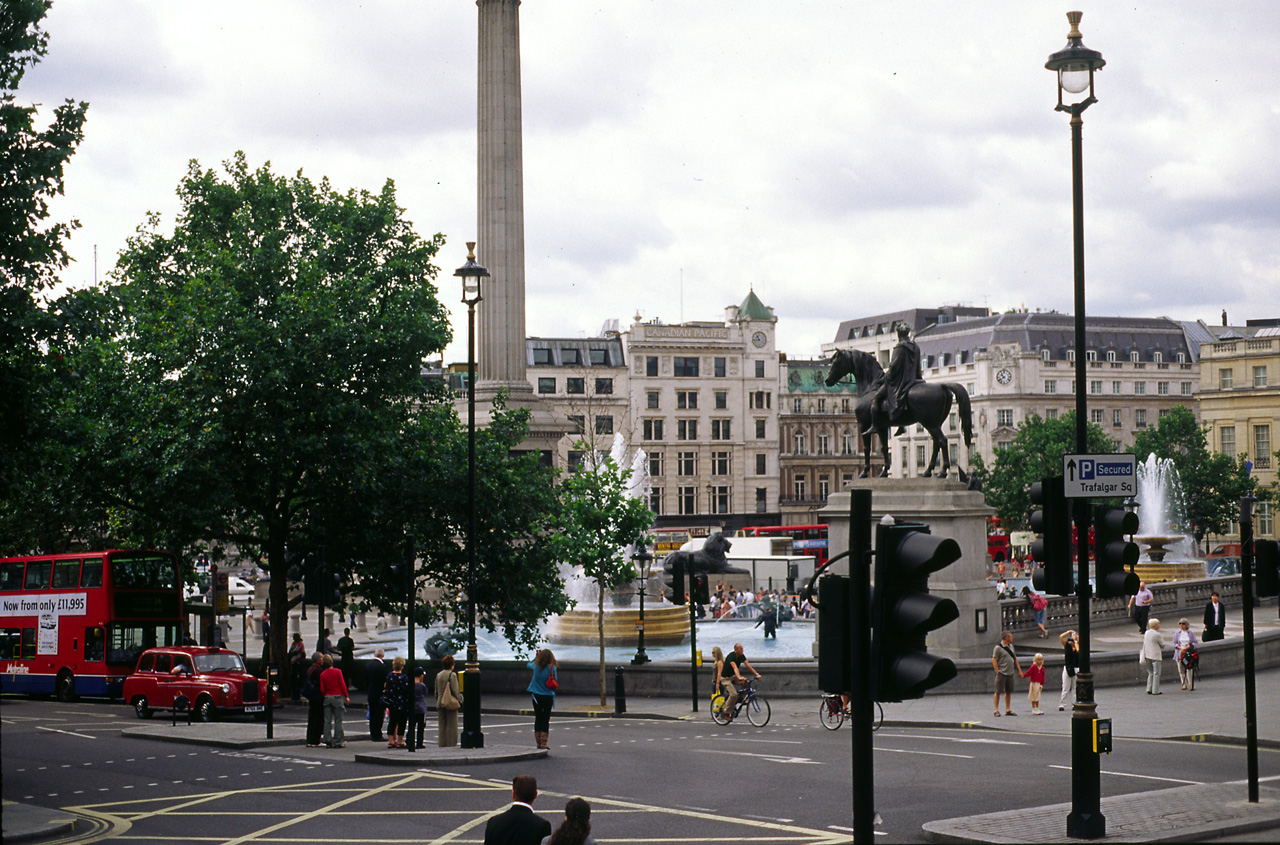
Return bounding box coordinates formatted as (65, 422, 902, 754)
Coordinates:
(0, 696, 1280, 844)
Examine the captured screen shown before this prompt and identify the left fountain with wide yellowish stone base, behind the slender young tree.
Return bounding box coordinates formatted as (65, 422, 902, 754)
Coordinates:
(547, 434, 689, 647)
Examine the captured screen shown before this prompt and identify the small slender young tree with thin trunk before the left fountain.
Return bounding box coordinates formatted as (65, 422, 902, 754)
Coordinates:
(549, 443, 653, 705)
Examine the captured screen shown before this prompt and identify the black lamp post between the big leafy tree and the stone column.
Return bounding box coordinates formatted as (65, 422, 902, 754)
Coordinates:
(453, 241, 489, 748)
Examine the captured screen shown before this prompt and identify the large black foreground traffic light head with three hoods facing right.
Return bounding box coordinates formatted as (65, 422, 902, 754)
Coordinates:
(872, 524, 960, 702)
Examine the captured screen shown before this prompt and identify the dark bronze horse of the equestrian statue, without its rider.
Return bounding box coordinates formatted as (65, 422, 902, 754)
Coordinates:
(827, 350, 973, 481)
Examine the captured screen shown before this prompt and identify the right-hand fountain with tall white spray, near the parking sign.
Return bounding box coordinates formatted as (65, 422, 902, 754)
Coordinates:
(1133, 453, 1204, 584)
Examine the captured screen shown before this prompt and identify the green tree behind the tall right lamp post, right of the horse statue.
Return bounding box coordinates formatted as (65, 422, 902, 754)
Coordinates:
(979, 411, 1116, 530)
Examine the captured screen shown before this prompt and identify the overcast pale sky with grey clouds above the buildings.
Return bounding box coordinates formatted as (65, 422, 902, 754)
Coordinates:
(18, 0, 1280, 361)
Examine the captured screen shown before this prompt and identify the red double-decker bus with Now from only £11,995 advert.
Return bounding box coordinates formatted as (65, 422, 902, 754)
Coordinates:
(0, 549, 182, 700)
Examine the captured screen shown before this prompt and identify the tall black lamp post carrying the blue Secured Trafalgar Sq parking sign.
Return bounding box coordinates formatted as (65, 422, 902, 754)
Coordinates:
(1044, 12, 1106, 839)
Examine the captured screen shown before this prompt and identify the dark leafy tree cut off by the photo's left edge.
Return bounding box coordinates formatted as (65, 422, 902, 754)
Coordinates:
(0, 0, 88, 552)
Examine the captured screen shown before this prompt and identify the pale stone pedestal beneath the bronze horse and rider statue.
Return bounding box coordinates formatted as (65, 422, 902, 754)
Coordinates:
(819, 479, 1000, 659)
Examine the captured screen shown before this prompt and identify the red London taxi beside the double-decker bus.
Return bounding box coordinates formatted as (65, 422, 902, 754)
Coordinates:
(124, 645, 268, 722)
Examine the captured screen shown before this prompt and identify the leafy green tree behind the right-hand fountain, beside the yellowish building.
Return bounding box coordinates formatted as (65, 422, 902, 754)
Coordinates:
(1132, 405, 1267, 544)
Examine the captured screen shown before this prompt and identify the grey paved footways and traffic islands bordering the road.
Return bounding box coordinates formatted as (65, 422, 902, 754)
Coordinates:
(3, 606, 1280, 844)
